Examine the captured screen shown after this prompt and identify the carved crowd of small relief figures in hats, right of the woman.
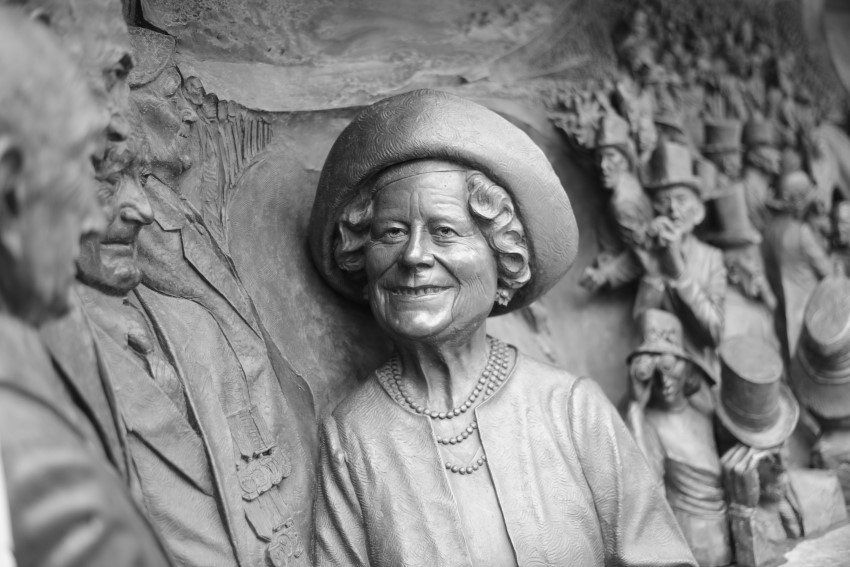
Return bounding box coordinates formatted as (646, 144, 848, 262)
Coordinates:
(552, 2, 850, 566)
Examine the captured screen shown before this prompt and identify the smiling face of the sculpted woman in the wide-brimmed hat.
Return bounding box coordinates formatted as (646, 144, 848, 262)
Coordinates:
(365, 171, 498, 340)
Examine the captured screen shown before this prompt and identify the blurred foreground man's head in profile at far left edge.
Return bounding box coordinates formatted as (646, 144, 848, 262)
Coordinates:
(0, 8, 105, 325)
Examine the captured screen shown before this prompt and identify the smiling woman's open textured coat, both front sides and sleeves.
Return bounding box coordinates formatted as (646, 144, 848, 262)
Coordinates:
(315, 355, 695, 567)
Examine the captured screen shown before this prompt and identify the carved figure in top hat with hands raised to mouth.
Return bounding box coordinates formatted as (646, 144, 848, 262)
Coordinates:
(635, 141, 727, 384)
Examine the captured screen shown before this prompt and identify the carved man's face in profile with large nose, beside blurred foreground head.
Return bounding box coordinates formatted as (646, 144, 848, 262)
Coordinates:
(77, 139, 153, 295)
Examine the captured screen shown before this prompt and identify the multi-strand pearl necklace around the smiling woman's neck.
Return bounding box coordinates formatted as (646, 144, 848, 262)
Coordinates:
(387, 337, 508, 474)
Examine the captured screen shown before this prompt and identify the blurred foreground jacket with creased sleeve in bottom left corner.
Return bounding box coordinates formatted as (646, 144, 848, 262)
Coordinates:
(0, 315, 170, 567)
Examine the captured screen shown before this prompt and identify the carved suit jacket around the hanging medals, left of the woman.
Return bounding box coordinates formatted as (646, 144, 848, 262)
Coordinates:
(136, 175, 317, 565)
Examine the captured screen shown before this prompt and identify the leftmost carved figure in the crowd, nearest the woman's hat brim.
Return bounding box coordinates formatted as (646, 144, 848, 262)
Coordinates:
(581, 111, 653, 292)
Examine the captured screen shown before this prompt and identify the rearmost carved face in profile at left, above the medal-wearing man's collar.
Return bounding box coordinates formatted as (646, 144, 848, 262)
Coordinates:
(132, 65, 198, 187)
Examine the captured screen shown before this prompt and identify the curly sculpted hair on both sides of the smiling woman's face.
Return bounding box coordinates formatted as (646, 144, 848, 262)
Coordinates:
(334, 170, 531, 302)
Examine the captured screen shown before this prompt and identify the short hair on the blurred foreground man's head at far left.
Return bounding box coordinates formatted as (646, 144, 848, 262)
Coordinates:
(0, 6, 102, 200)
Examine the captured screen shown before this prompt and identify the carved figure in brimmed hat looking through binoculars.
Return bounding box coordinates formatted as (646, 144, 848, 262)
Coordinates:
(628, 309, 733, 567)
